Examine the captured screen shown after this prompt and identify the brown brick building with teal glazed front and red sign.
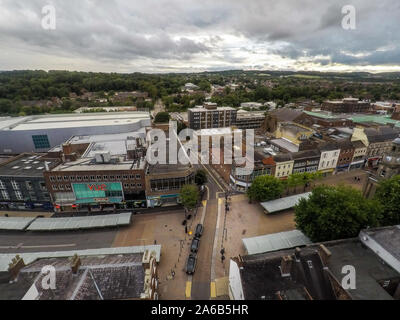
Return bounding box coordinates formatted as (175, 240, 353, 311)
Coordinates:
(44, 133, 146, 211)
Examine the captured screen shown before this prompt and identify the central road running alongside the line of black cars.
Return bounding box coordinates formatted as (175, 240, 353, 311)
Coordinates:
(191, 162, 224, 300)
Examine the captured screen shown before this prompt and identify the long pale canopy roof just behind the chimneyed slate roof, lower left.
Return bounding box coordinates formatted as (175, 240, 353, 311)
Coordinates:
(0, 245, 161, 272)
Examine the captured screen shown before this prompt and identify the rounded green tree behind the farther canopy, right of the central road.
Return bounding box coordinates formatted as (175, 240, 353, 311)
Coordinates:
(247, 176, 285, 201)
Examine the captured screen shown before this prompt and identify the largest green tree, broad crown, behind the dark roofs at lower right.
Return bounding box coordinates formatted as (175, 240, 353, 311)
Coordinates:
(295, 186, 382, 242)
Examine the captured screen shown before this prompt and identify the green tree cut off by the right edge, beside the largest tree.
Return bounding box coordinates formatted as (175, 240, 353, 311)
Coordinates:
(375, 176, 400, 226)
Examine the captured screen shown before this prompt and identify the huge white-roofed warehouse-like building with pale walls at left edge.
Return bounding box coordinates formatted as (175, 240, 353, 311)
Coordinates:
(0, 112, 151, 154)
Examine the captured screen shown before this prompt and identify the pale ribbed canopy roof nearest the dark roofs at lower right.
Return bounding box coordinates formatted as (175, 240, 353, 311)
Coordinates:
(242, 230, 312, 255)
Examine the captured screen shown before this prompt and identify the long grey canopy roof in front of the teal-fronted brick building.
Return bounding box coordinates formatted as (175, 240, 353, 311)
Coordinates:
(27, 212, 132, 231)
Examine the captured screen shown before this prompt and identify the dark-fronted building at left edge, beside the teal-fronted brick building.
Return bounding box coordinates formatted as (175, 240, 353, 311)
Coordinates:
(0, 154, 61, 211)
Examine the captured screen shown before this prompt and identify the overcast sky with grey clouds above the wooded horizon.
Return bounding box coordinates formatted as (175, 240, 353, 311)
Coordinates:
(0, 0, 400, 73)
